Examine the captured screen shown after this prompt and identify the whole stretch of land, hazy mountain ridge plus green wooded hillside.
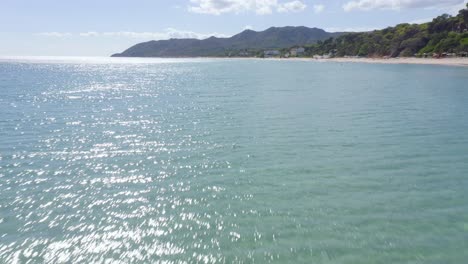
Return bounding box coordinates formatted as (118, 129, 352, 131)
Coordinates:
(112, 4, 468, 58)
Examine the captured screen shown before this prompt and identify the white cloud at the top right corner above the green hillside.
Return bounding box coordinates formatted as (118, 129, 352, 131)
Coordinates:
(343, 0, 465, 11)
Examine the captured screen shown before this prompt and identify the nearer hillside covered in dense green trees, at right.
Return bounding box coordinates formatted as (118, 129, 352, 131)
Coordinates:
(306, 4, 468, 57)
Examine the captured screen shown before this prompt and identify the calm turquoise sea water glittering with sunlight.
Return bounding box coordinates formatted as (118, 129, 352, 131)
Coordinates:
(0, 56, 468, 264)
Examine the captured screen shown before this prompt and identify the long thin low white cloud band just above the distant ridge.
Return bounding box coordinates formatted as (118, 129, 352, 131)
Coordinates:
(34, 28, 229, 40)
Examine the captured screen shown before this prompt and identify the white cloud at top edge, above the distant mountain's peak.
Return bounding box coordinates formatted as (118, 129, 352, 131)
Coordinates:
(188, 0, 307, 15)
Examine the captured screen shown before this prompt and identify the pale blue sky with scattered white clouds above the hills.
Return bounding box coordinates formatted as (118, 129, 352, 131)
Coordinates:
(0, 0, 468, 56)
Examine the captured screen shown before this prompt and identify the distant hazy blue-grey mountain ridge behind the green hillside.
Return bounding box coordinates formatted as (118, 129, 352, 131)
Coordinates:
(112, 26, 343, 57)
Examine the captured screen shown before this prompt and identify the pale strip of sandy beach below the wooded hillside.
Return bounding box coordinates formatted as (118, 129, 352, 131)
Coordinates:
(324, 58, 468, 67)
